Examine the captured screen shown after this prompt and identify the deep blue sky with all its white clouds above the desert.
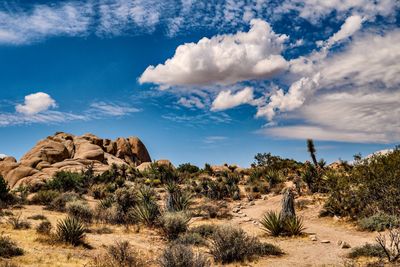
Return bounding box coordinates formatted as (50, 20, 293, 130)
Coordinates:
(0, 0, 400, 166)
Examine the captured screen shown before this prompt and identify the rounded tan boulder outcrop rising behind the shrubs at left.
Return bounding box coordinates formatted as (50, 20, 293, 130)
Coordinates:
(0, 132, 151, 188)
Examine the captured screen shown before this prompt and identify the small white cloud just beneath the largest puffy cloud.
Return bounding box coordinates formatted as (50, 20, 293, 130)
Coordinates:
(211, 87, 254, 111)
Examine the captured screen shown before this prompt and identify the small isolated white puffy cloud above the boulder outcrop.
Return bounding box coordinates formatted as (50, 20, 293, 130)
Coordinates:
(15, 92, 57, 115)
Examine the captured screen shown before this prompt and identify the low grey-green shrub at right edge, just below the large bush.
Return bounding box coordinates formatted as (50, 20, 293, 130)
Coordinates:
(358, 212, 400, 231)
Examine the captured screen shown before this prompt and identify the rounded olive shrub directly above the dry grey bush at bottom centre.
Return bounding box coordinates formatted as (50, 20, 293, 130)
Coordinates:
(160, 212, 190, 240)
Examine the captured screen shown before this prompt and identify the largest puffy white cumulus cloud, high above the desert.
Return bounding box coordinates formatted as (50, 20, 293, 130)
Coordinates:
(139, 19, 288, 86)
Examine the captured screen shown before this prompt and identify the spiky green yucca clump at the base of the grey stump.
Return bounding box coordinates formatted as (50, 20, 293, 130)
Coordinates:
(260, 211, 305, 236)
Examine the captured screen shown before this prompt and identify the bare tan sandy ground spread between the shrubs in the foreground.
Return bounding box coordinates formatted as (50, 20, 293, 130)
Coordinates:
(0, 195, 376, 266)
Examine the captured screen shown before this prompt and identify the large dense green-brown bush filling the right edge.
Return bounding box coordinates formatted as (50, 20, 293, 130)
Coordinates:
(325, 148, 400, 219)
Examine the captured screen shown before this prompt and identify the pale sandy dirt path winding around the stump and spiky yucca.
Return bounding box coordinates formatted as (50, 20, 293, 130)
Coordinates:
(228, 195, 376, 266)
